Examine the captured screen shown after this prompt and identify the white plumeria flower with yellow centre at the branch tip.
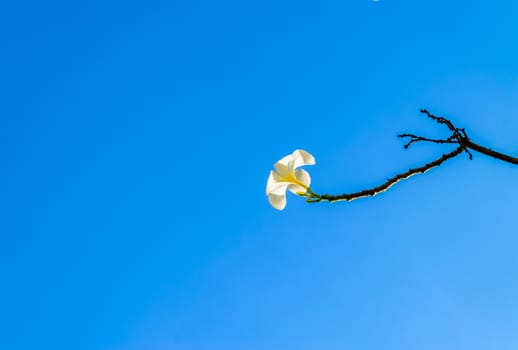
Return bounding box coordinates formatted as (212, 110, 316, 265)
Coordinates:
(266, 149, 315, 210)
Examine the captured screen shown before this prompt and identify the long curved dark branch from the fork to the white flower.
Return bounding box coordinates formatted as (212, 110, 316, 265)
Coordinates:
(304, 146, 464, 203)
